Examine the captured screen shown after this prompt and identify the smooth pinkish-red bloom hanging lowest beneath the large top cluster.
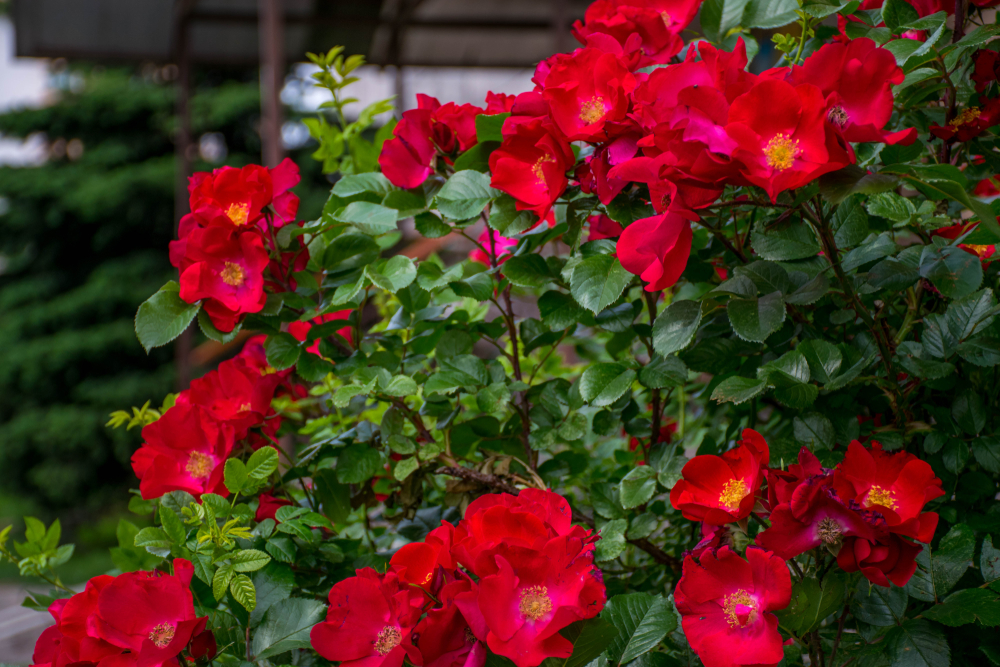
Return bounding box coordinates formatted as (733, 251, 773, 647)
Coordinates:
(616, 211, 692, 292)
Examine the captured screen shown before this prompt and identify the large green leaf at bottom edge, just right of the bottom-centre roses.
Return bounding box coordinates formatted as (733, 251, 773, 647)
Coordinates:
(601, 593, 677, 664)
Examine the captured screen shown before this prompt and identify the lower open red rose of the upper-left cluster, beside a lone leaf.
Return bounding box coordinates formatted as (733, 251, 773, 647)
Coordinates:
(170, 227, 268, 332)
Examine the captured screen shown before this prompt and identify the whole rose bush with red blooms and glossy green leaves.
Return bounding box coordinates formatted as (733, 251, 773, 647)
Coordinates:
(0, 5, 1000, 667)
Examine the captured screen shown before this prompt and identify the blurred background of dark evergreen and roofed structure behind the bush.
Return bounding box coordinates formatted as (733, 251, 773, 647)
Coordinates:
(0, 0, 608, 665)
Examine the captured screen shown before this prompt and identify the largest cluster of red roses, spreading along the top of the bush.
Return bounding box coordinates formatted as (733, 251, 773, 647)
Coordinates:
(379, 0, 936, 291)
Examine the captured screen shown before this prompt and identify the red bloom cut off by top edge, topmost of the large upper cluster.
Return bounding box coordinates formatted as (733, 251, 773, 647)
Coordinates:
(573, 0, 701, 67)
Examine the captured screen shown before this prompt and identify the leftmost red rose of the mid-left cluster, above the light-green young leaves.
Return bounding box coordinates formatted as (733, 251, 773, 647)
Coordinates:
(132, 405, 234, 500)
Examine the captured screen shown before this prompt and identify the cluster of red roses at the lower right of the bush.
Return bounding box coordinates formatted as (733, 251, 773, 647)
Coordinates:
(670, 429, 944, 667)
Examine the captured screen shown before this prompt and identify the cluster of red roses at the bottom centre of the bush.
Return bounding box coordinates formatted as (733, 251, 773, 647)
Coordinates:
(312, 489, 605, 667)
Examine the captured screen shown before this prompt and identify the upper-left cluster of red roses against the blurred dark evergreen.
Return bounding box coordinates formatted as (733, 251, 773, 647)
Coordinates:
(170, 158, 309, 333)
